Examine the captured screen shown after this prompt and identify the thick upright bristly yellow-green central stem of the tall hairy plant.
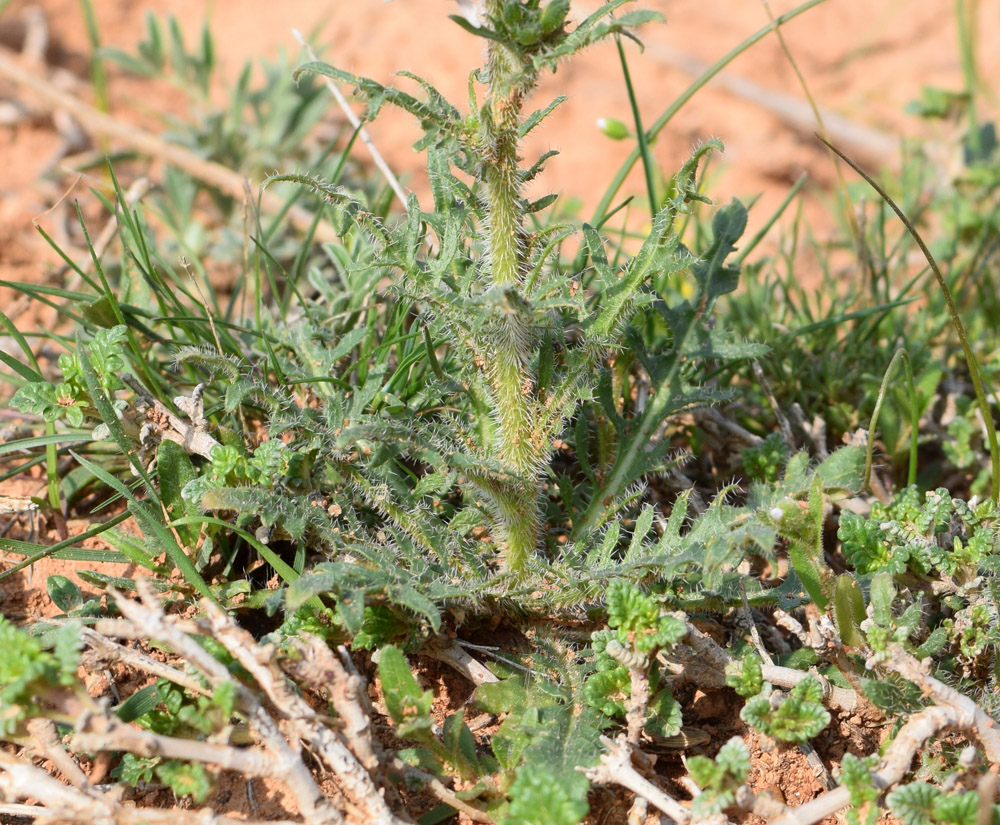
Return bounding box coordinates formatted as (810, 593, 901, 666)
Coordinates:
(482, 0, 544, 573)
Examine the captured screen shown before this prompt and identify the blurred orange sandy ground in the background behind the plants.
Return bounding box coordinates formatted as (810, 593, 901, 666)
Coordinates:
(0, 0, 1000, 280)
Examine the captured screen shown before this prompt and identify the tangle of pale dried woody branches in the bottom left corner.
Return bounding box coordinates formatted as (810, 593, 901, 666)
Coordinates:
(0, 581, 426, 825)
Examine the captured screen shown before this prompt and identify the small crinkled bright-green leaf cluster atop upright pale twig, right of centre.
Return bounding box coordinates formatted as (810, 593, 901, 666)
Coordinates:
(584, 580, 686, 736)
